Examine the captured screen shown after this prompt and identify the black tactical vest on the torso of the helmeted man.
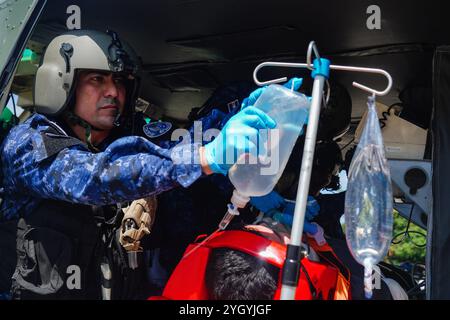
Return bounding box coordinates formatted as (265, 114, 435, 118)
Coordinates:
(7, 200, 145, 299)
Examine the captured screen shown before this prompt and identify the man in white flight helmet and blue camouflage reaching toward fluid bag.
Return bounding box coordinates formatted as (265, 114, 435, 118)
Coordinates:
(0, 31, 276, 299)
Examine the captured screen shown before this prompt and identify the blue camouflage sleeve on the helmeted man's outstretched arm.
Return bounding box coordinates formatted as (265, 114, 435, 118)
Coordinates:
(10, 129, 202, 205)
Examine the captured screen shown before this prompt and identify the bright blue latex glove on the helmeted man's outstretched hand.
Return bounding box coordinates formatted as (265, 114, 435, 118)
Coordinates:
(205, 107, 276, 175)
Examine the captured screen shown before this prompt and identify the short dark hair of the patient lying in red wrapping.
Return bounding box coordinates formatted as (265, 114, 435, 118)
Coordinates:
(205, 248, 280, 300)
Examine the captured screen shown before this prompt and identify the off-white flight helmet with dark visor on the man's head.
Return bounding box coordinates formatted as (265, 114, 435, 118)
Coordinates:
(34, 30, 139, 116)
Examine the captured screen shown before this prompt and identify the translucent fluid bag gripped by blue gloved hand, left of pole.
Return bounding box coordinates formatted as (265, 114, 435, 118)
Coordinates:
(228, 84, 311, 197)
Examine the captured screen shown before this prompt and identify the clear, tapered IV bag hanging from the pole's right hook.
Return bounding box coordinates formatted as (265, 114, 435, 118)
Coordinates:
(345, 97, 393, 298)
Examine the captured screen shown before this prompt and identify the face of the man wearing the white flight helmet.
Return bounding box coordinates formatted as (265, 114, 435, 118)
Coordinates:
(74, 71, 126, 130)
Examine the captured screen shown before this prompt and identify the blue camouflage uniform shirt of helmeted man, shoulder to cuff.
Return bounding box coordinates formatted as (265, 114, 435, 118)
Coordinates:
(1, 114, 202, 219)
